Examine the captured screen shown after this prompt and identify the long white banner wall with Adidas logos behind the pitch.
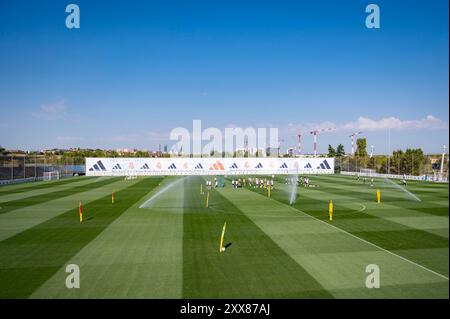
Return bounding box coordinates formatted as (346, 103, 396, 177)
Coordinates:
(86, 157, 334, 176)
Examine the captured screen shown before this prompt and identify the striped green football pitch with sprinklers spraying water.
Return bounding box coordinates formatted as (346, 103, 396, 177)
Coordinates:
(0, 175, 449, 298)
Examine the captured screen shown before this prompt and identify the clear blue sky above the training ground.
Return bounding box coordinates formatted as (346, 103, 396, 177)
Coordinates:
(0, 0, 449, 153)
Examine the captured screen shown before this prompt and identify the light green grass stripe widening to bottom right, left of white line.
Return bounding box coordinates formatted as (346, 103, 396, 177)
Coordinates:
(219, 187, 448, 298)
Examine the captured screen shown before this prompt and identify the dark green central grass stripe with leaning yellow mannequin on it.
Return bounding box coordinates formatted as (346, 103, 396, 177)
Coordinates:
(183, 177, 332, 298)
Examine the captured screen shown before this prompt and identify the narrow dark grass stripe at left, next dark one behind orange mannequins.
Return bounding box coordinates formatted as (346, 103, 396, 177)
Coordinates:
(0, 177, 120, 214)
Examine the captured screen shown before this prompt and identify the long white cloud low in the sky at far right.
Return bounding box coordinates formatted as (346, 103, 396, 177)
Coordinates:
(342, 115, 448, 131)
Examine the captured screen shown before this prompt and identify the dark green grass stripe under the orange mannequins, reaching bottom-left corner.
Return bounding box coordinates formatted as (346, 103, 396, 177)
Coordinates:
(0, 178, 159, 298)
